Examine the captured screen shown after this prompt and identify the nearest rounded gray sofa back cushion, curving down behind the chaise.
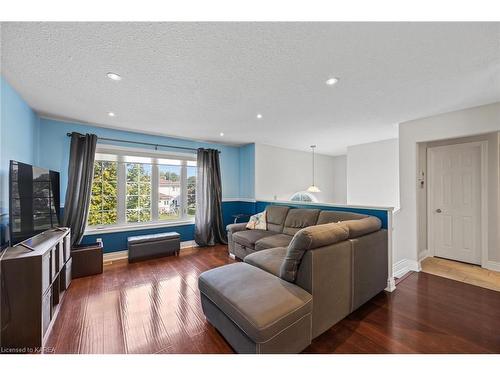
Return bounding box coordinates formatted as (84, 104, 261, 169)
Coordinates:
(280, 223, 349, 282)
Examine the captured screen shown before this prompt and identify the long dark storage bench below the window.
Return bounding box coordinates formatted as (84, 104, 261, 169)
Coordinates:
(127, 232, 181, 262)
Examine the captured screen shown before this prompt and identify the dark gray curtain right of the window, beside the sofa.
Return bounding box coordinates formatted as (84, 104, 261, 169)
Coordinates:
(194, 148, 227, 246)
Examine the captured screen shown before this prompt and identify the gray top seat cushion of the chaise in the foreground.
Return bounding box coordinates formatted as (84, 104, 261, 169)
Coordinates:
(198, 263, 312, 343)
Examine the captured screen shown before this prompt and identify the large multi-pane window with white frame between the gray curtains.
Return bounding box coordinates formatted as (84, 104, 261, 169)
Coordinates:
(87, 146, 197, 228)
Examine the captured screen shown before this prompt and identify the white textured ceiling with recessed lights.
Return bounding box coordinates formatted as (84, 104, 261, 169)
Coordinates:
(2, 23, 500, 154)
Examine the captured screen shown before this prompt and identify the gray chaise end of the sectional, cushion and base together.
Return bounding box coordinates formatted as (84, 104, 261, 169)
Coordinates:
(198, 263, 312, 353)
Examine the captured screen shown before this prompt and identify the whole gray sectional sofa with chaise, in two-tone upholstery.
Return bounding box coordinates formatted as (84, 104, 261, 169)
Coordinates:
(199, 205, 388, 353)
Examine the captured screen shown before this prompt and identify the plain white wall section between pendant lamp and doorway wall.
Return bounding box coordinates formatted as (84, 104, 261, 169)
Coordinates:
(347, 138, 399, 209)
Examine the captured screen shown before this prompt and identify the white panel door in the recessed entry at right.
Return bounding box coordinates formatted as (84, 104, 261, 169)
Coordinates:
(428, 143, 481, 264)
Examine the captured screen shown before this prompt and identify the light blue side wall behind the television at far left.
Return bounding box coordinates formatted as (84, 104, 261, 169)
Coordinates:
(0, 76, 39, 246)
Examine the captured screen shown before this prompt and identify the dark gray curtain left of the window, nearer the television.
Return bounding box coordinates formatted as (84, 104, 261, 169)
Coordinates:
(63, 133, 97, 245)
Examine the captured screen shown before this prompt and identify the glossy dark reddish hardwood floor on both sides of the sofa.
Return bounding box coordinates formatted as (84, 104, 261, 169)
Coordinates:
(46, 246, 500, 353)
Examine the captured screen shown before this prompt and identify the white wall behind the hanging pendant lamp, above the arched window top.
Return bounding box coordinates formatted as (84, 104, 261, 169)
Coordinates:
(255, 144, 345, 203)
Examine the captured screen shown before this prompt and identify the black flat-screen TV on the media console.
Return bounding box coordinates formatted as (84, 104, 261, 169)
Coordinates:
(9, 160, 60, 246)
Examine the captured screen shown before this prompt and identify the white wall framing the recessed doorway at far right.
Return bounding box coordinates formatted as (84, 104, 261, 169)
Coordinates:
(393, 103, 500, 263)
